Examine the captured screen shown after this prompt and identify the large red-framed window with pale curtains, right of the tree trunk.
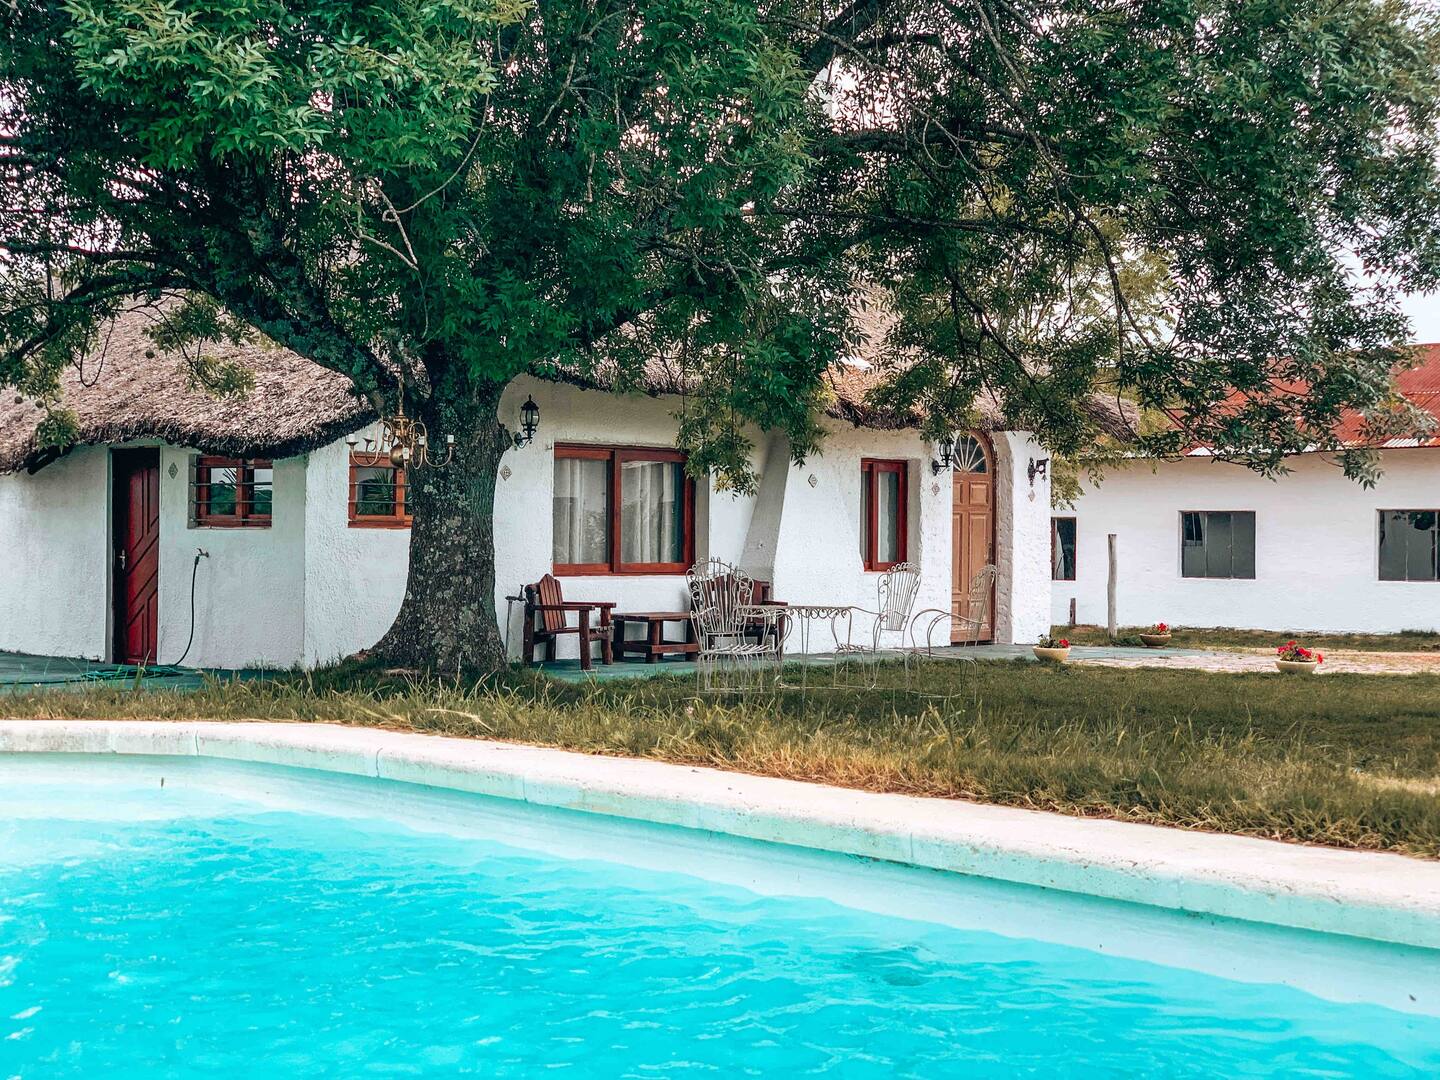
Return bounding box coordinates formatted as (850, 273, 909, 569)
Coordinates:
(554, 446, 696, 573)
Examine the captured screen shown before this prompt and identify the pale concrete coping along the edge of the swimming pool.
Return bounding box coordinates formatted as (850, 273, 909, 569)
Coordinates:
(8, 720, 1440, 949)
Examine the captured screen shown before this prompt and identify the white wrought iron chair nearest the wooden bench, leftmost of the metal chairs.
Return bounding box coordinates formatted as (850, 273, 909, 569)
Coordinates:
(685, 559, 783, 694)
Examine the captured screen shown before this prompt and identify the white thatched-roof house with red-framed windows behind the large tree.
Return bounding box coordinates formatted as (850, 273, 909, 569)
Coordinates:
(0, 312, 1100, 668)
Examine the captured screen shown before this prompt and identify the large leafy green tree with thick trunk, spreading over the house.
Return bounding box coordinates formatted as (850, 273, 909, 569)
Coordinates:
(0, 0, 1440, 668)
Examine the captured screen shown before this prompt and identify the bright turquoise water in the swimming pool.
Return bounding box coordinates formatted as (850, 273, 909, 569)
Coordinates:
(0, 757, 1440, 1077)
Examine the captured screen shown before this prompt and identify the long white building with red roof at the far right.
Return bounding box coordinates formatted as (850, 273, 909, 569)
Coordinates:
(1051, 346, 1440, 632)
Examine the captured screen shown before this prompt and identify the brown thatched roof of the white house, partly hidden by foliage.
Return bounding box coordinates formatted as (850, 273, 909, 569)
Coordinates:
(0, 310, 1129, 474)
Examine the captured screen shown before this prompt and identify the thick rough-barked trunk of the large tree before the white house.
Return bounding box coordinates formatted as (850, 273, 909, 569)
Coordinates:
(373, 386, 511, 672)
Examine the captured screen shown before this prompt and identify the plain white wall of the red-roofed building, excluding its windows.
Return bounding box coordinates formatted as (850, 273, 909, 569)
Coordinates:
(1051, 449, 1440, 632)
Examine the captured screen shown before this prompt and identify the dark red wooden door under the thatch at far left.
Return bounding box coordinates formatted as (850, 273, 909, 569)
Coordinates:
(112, 449, 160, 664)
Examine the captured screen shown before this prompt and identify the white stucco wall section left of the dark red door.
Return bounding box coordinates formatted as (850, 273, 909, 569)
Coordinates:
(0, 446, 111, 660)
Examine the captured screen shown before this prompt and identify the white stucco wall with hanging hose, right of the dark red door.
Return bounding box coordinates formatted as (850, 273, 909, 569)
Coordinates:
(158, 446, 305, 668)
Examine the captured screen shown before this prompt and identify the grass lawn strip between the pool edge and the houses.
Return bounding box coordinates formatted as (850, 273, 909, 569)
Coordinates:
(3, 661, 1440, 857)
